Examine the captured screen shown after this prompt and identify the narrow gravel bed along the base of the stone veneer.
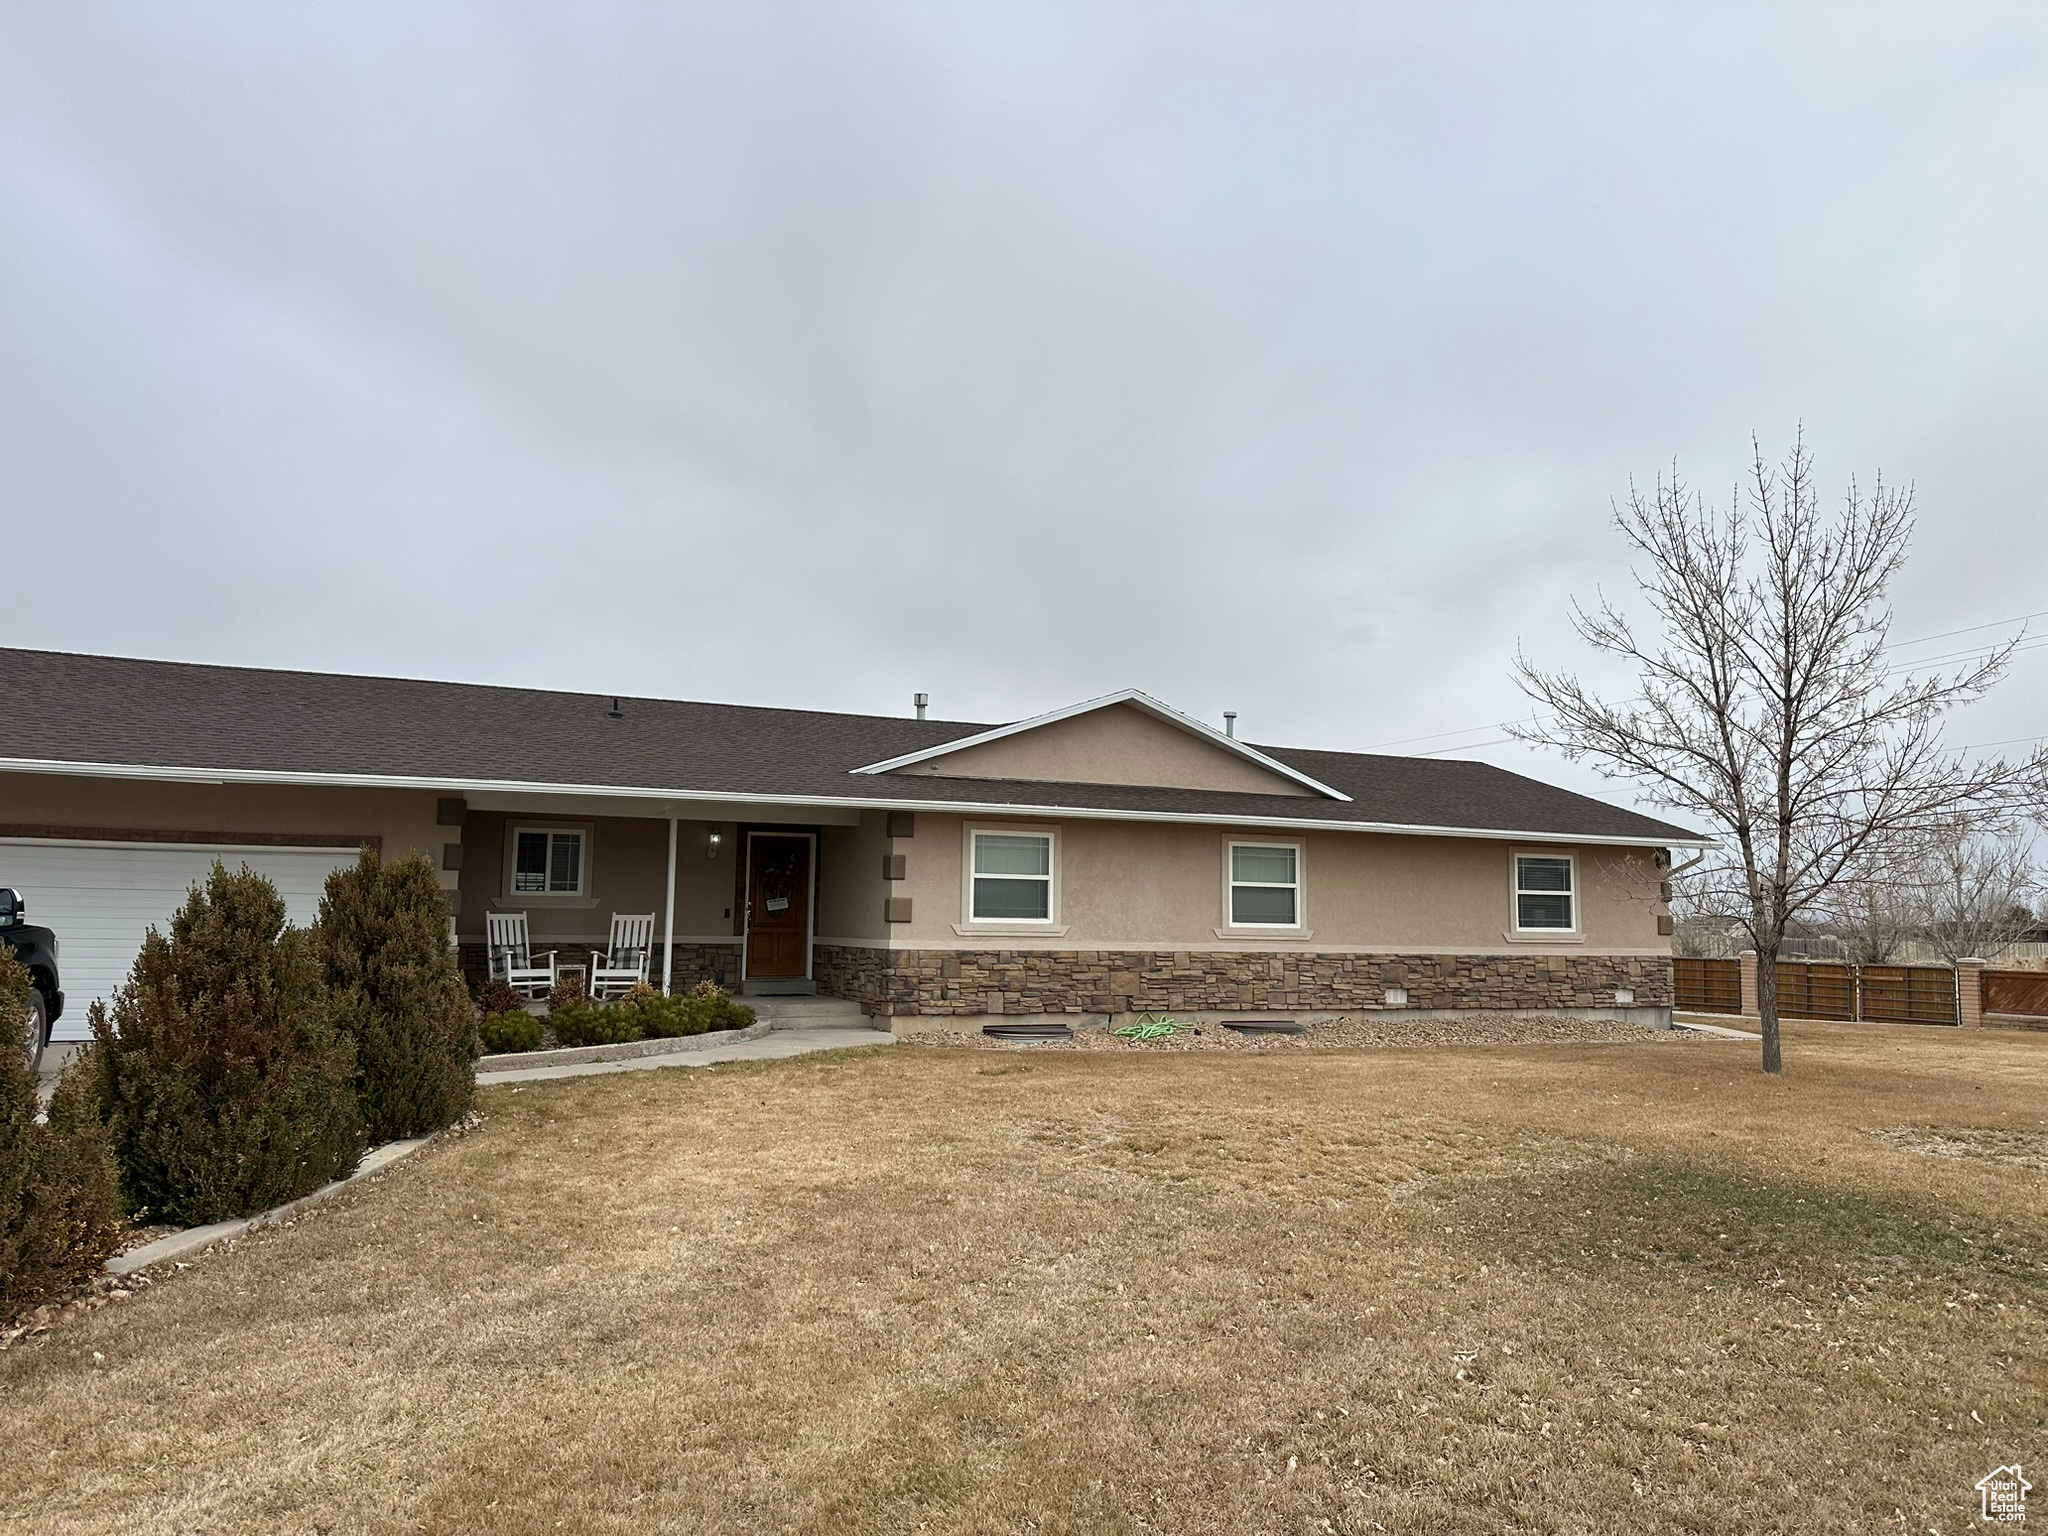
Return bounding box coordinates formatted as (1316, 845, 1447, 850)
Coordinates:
(899, 1014, 1702, 1051)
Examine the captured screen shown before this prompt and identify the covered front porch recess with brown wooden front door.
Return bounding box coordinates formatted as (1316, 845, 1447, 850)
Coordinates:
(440, 795, 887, 997)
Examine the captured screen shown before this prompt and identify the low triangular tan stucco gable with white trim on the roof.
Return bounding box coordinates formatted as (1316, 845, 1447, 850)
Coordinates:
(854, 688, 1350, 801)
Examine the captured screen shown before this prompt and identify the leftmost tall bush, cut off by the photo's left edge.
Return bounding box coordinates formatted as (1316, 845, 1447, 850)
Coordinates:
(0, 944, 121, 1327)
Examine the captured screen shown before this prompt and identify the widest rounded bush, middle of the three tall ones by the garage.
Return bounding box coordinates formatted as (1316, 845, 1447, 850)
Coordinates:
(92, 864, 362, 1225)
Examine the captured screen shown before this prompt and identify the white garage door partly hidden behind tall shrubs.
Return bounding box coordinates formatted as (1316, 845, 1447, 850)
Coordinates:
(0, 838, 356, 1040)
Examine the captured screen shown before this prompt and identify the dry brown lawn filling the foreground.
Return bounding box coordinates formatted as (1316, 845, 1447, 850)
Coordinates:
(0, 1026, 2048, 1536)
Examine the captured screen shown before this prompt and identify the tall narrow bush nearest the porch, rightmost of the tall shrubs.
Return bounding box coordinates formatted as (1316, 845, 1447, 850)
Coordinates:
(317, 848, 477, 1143)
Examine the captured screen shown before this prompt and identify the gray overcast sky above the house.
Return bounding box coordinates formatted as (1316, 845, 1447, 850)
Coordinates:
(0, 0, 2048, 819)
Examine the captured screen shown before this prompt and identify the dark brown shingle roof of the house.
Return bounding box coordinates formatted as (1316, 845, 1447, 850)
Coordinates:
(0, 649, 1698, 842)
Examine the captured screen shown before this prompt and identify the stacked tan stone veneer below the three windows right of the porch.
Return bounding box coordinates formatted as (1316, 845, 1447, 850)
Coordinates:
(817, 944, 1671, 1018)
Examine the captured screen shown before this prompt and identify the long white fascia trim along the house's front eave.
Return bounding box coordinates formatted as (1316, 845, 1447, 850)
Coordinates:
(0, 758, 1720, 850)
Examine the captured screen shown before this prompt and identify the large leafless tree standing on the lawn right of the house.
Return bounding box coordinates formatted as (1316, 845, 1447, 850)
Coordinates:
(1516, 438, 2017, 1073)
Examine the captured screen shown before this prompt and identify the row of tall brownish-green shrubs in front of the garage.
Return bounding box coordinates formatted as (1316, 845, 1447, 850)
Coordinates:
(0, 850, 477, 1323)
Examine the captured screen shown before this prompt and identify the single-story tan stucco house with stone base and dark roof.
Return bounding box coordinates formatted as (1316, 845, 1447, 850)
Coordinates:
(0, 649, 1704, 1038)
